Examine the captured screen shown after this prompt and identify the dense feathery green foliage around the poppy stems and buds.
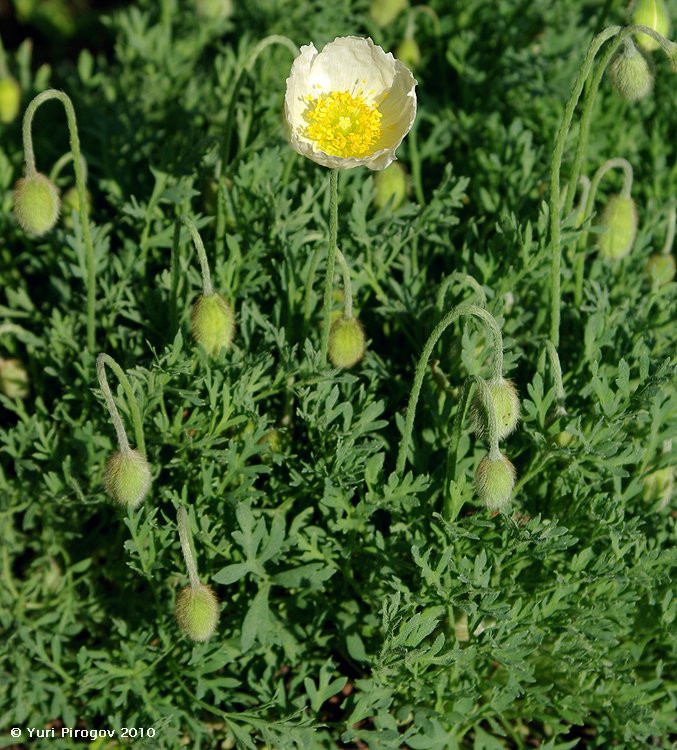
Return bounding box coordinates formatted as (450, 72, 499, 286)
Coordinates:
(0, 0, 677, 750)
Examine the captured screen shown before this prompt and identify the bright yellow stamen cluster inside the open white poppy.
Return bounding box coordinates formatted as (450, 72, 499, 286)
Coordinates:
(303, 91, 381, 158)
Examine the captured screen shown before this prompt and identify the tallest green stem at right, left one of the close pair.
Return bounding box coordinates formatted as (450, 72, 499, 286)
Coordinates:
(549, 26, 621, 347)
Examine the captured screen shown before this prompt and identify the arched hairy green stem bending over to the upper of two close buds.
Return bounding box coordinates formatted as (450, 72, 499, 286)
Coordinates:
(396, 304, 503, 476)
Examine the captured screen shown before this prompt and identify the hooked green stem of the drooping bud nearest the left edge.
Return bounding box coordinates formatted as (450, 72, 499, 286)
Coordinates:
(23, 89, 96, 351)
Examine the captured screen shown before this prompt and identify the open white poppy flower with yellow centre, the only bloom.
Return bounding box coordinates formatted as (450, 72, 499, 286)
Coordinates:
(284, 36, 416, 170)
